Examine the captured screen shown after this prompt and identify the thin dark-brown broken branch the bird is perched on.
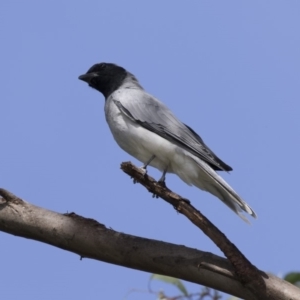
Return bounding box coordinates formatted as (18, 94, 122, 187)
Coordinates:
(121, 162, 298, 299)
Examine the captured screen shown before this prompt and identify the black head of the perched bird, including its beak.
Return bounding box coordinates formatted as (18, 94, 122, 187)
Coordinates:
(78, 63, 127, 98)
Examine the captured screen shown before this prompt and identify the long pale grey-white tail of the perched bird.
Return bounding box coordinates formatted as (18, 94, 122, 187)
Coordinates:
(186, 157, 257, 223)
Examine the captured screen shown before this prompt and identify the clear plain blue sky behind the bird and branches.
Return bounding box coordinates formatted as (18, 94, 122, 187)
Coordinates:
(0, 0, 300, 300)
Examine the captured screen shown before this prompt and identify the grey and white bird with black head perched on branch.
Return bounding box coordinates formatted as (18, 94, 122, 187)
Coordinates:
(78, 62, 257, 223)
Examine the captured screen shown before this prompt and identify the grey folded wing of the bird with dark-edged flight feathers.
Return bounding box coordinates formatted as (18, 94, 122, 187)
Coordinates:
(112, 90, 232, 171)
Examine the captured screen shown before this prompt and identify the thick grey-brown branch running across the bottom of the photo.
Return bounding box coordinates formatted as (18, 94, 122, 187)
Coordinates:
(0, 189, 300, 300)
